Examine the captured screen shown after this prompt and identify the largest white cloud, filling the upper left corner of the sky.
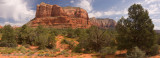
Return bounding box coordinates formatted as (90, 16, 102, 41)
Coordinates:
(0, 0, 35, 24)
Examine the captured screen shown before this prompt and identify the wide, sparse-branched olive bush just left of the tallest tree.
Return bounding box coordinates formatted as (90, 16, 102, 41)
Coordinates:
(75, 26, 115, 52)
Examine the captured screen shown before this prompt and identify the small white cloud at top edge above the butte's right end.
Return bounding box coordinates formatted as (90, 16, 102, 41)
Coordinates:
(76, 0, 93, 12)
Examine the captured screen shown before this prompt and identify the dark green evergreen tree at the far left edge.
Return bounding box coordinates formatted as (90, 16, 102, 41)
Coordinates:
(0, 25, 17, 47)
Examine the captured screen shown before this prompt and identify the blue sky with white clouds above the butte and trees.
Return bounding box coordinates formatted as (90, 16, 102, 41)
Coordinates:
(0, 0, 160, 30)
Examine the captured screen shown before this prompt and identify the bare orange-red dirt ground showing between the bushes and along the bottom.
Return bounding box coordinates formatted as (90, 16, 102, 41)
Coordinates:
(0, 35, 160, 58)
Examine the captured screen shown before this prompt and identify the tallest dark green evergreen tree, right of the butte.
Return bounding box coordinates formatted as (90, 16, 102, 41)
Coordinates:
(116, 4, 155, 52)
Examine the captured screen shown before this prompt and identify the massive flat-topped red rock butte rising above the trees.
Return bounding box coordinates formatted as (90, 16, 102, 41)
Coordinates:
(27, 2, 91, 28)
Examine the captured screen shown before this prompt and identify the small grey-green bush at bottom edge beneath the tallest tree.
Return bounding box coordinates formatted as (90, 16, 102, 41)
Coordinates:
(127, 47, 145, 58)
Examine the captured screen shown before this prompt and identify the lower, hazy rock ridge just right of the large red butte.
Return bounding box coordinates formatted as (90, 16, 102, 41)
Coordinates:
(90, 17, 116, 28)
